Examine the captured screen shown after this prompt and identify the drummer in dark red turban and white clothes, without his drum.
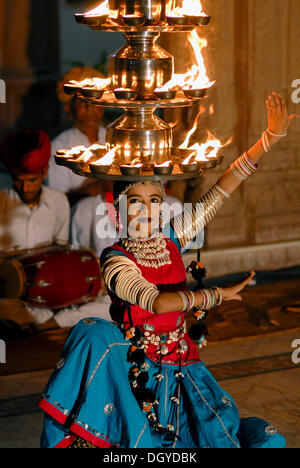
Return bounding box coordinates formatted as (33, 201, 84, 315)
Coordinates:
(0, 130, 108, 338)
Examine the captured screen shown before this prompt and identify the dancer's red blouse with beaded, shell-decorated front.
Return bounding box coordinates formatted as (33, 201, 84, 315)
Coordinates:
(105, 238, 200, 365)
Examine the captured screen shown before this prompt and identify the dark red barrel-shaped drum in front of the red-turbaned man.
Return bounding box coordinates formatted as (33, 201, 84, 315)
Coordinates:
(0, 246, 102, 309)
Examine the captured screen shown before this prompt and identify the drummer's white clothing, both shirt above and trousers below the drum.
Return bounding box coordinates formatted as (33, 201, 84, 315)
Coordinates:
(0, 187, 111, 327)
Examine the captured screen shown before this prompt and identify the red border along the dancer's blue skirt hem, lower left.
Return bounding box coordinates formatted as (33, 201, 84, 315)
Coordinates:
(38, 398, 118, 448)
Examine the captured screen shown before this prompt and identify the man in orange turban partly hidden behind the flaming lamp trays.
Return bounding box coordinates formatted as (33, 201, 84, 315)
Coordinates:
(48, 67, 106, 205)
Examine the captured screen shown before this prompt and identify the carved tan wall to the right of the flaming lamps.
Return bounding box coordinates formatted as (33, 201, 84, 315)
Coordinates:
(162, 0, 300, 274)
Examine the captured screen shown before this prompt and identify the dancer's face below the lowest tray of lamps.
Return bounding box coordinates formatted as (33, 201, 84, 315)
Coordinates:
(123, 183, 162, 238)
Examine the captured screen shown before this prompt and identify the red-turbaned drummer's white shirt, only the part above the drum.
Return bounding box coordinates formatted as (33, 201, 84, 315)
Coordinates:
(0, 187, 70, 250)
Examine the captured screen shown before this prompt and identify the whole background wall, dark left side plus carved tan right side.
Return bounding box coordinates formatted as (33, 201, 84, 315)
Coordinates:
(0, 0, 300, 274)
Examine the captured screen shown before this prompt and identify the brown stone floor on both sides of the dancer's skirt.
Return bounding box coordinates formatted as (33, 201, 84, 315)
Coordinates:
(0, 328, 300, 448)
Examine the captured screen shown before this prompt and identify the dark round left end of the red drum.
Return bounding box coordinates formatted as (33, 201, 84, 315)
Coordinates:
(0, 259, 26, 299)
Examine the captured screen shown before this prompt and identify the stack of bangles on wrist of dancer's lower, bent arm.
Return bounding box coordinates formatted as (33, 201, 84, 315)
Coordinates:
(178, 287, 223, 313)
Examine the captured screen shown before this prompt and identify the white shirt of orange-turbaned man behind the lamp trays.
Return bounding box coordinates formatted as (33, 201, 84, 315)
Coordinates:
(48, 127, 106, 193)
